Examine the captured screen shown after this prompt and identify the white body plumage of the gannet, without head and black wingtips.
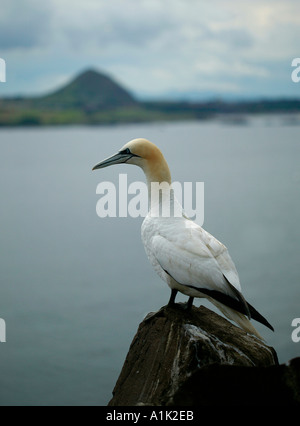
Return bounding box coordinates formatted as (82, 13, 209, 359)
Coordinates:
(142, 215, 241, 297)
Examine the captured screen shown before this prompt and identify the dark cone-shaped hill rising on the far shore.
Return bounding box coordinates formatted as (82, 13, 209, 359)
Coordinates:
(35, 70, 138, 112)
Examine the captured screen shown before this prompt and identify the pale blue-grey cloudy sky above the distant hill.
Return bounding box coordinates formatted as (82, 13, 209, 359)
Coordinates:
(0, 0, 300, 97)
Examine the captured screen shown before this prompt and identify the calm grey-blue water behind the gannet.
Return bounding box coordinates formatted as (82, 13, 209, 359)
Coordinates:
(0, 118, 300, 405)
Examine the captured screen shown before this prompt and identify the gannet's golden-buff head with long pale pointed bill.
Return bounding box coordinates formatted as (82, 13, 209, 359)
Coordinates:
(93, 139, 171, 183)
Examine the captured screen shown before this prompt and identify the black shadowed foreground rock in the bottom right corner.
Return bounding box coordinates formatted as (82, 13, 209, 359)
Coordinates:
(171, 358, 300, 407)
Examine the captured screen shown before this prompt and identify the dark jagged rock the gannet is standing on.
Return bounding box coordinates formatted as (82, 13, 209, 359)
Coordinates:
(108, 305, 300, 406)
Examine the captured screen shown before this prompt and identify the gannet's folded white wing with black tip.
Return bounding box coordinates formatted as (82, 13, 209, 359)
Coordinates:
(151, 223, 250, 318)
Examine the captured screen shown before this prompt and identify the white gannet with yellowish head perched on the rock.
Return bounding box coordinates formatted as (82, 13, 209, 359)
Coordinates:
(93, 139, 274, 339)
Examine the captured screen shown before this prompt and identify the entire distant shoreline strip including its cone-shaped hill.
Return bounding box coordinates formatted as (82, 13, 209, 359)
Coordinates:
(0, 70, 300, 126)
